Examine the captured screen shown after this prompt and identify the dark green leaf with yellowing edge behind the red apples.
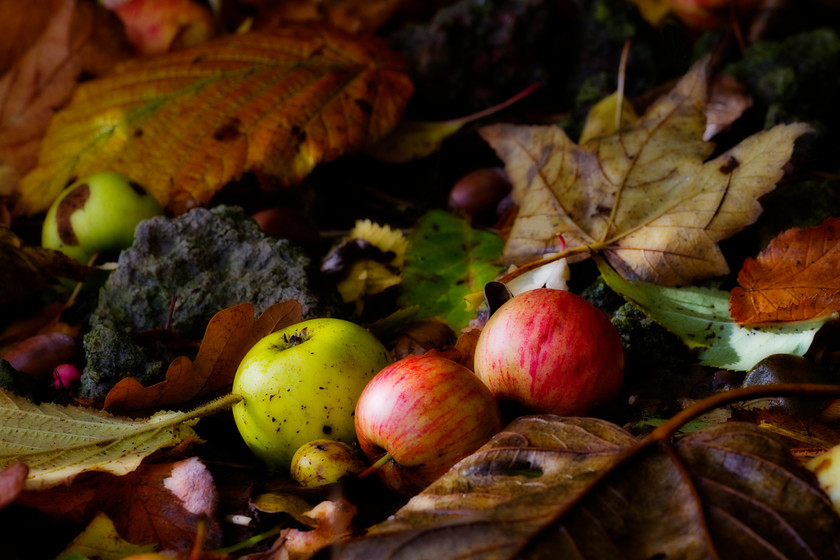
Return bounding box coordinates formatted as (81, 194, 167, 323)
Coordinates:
(401, 210, 504, 332)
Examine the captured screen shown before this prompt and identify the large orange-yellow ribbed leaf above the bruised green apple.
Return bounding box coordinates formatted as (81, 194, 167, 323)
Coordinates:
(17, 24, 413, 214)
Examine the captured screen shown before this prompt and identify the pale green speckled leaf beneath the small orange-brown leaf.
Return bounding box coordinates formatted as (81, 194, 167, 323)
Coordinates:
(597, 259, 829, 371)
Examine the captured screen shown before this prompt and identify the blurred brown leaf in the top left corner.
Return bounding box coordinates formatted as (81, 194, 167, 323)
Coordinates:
(0, 0, 131, 194)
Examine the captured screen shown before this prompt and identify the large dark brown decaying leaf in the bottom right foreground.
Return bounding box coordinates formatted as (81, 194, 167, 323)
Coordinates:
(334, 416, 840, 560)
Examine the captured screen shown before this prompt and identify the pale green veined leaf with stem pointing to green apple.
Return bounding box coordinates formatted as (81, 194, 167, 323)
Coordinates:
(0, 390, 239, 490)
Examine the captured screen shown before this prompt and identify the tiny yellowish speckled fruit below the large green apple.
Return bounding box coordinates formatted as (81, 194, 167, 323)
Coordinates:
(292, 439, 366, 488)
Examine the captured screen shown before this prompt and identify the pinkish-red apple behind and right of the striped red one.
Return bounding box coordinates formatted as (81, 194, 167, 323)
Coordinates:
(475, 288, 624, 416)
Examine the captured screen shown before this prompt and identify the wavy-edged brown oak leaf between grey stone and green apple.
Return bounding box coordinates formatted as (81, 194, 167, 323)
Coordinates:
(103, 301, 303, 411)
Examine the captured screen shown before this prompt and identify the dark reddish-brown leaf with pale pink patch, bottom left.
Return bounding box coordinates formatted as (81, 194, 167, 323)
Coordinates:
(18, 457, 221, 550)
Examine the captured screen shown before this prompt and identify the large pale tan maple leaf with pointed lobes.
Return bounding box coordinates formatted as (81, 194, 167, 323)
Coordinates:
(480, 59, 809, 285)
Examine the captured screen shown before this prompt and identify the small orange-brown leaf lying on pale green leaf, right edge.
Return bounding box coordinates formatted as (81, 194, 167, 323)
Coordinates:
(729, 218, 840, 325)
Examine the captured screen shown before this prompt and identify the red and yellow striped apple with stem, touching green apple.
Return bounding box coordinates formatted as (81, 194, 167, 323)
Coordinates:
(356, 354, 502, 495)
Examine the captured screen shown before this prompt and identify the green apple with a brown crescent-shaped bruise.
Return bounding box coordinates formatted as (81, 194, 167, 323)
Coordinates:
(41, 171, 163, 262)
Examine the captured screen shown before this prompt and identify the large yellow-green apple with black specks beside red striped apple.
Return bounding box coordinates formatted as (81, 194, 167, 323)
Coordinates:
(233, 318, 391, 470)
